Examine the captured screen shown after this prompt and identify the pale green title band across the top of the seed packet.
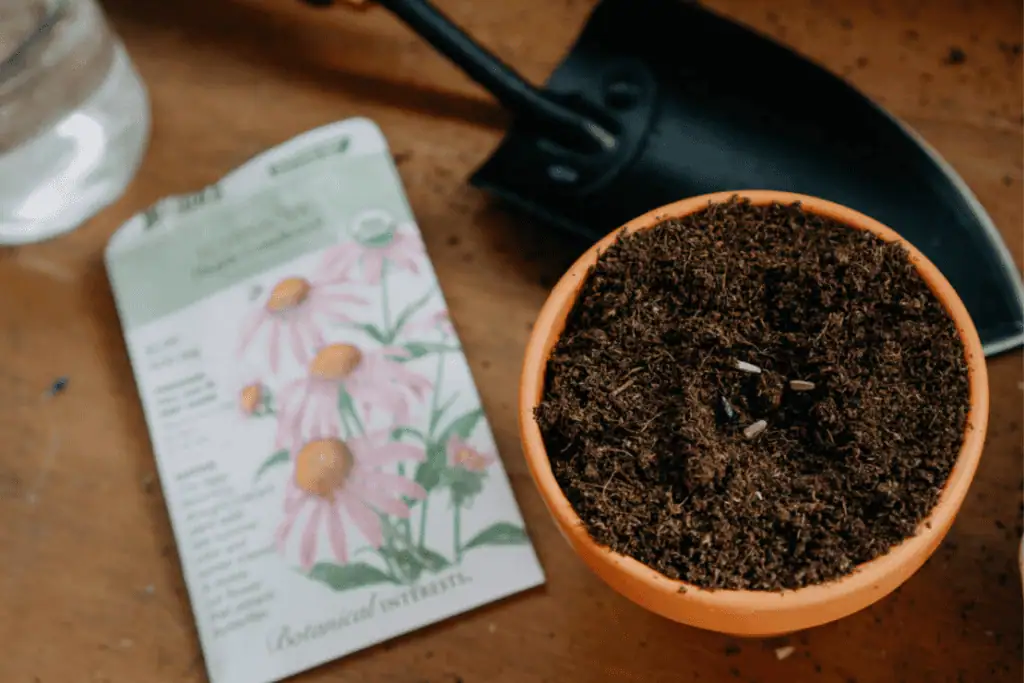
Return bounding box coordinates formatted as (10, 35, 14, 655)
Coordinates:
(108, 154, 412, 330)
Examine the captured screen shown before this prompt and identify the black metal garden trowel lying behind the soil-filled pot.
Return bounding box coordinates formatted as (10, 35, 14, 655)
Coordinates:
(307, 0, 1024, 355)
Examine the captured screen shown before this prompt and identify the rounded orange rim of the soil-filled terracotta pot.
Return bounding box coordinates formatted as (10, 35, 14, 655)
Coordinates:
(519, 190, 989, 611)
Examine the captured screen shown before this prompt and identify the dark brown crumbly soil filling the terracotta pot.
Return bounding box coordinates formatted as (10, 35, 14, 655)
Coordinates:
(537, 201, 968, 591)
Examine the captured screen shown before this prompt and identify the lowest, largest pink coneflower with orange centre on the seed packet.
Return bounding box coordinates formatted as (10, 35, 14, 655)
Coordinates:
(274, 432, 427, 569)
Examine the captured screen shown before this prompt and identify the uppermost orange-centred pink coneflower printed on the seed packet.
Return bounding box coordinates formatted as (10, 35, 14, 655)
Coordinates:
(239, 256, 367, 374)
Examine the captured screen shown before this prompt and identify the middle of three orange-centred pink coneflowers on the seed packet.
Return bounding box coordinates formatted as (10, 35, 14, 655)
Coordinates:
(278, 343, 431, 449)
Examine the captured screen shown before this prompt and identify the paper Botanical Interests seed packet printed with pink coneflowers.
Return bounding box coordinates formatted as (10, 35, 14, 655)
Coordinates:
(105, 119, 544, 683)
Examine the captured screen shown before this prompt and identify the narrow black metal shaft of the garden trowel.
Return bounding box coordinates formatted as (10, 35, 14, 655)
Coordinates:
(305, 0, 616, 153)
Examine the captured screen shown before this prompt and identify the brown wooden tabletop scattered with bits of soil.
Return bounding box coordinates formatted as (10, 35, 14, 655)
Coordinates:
(0, 0, 1024, 683)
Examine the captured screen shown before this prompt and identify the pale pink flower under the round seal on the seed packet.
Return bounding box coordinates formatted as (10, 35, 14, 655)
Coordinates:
(315, 209, 425, 285)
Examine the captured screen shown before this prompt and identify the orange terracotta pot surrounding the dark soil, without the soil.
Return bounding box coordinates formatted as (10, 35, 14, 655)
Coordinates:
(519, 190, 989, 636)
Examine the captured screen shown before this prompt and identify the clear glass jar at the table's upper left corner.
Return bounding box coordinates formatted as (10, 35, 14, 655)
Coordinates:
(0, 0, 150, 244)
